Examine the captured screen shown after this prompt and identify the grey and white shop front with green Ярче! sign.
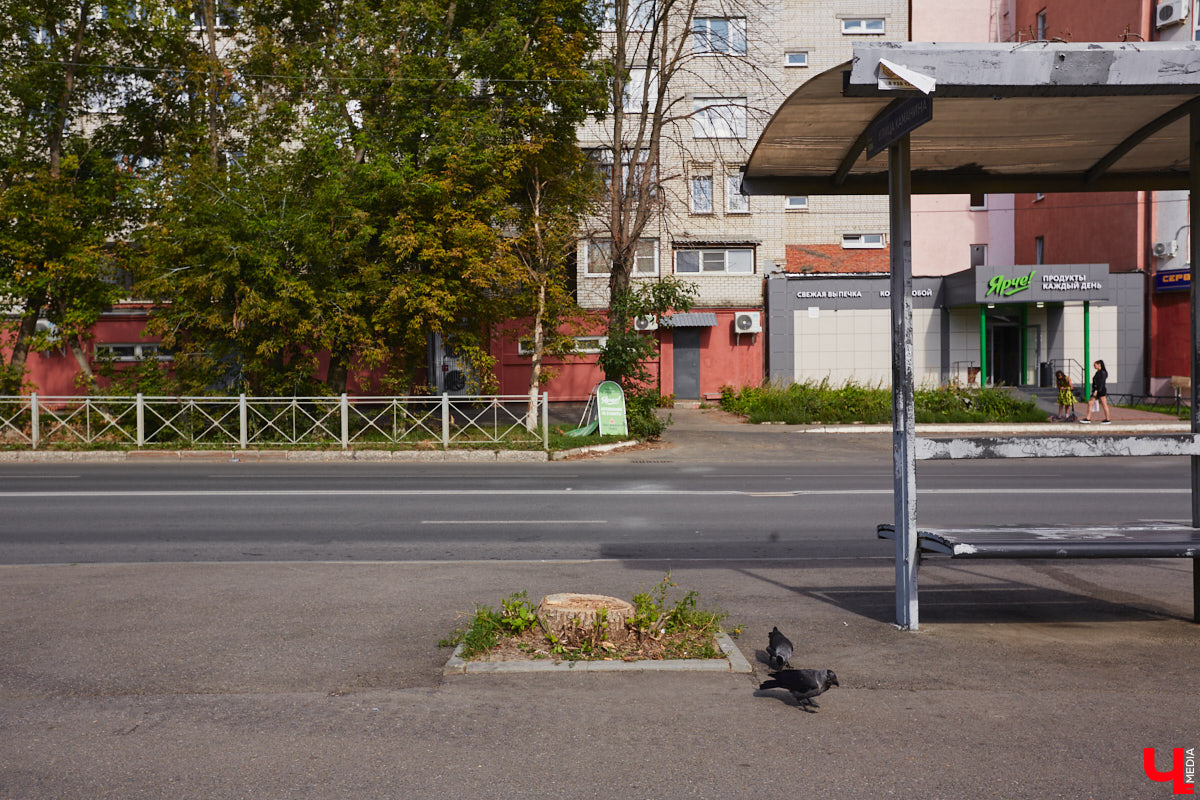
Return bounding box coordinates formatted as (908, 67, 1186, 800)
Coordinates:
(767, 264, 1145, 393)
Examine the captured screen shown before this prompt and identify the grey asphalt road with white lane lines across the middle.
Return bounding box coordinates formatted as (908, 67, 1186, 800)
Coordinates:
(0, 435, 1189, 564)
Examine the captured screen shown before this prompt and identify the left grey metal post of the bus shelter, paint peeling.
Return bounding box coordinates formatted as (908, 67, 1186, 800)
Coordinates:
(888, 134, 920, 631)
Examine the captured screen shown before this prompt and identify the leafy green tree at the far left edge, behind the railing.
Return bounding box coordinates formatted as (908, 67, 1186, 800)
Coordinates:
(0, 0, 185, 392)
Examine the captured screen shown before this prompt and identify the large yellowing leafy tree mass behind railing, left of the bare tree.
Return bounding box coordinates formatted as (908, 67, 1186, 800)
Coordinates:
(145, 0, 604, 392)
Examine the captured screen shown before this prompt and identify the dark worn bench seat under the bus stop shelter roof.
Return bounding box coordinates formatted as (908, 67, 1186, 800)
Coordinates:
(876, 523, 1200, 622)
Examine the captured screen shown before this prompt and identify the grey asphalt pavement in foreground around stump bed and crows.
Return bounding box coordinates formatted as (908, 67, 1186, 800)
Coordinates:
(0, 557, 1200, 800)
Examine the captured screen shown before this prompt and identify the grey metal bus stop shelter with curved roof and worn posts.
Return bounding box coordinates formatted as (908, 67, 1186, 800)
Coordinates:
(743, 42, 1200, 630)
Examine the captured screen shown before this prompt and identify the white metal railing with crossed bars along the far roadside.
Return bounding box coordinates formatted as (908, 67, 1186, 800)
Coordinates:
(0, 393, 550, 450)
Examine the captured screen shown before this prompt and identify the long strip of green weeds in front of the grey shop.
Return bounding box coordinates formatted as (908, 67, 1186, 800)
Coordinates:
(721, 379, 1046, 425)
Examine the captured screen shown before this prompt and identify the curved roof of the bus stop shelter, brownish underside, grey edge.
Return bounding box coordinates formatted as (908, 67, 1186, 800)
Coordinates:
(743, 42, 1200, 194)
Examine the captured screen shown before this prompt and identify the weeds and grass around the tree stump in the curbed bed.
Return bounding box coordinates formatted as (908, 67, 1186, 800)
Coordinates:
(438, 572, 740, 661)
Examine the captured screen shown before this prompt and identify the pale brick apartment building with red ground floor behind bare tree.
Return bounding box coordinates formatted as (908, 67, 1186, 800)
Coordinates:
(497, 0, 908, 399)
